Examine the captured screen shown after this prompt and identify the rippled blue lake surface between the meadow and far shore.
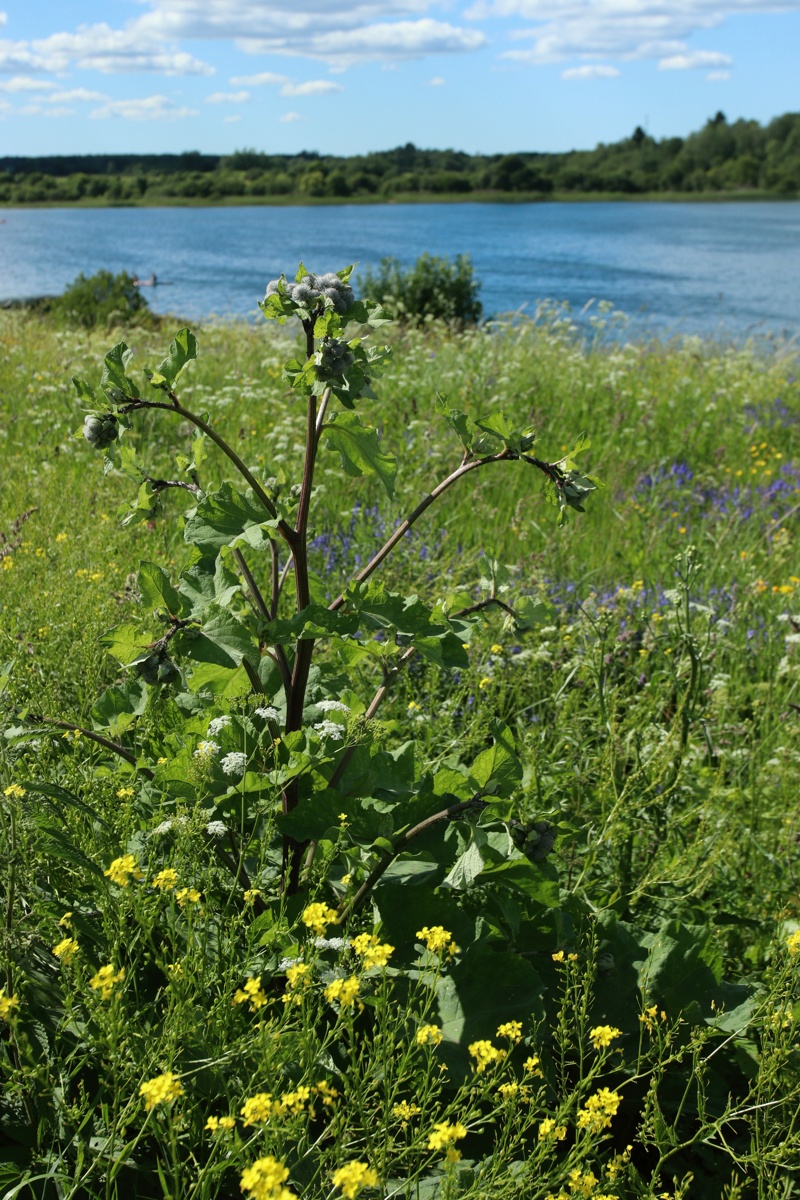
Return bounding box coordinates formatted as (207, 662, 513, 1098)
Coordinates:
(0, 202, 800, 340)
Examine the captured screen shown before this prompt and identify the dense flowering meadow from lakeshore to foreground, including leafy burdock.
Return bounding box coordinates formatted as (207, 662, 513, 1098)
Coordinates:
(0, 274, 800, 1200)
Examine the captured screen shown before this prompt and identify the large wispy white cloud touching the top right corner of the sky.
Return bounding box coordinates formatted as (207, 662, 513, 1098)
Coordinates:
(464, 0, 800, 65)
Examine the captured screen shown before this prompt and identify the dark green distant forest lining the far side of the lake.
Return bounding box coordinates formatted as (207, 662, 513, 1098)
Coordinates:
(0, 113, 800, 204)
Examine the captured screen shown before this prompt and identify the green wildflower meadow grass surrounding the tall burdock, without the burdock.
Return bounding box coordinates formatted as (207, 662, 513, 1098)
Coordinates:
(0, 310, 800, 1200)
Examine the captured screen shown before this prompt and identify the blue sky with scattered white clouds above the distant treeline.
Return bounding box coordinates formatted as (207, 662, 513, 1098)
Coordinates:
(0, 0, 800, 155)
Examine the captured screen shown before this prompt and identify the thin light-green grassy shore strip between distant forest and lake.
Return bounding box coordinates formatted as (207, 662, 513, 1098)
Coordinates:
(0, 188, 800, 210)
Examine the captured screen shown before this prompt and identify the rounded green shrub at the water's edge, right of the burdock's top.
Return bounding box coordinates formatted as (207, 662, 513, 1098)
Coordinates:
(363, 254, 483, 326)
